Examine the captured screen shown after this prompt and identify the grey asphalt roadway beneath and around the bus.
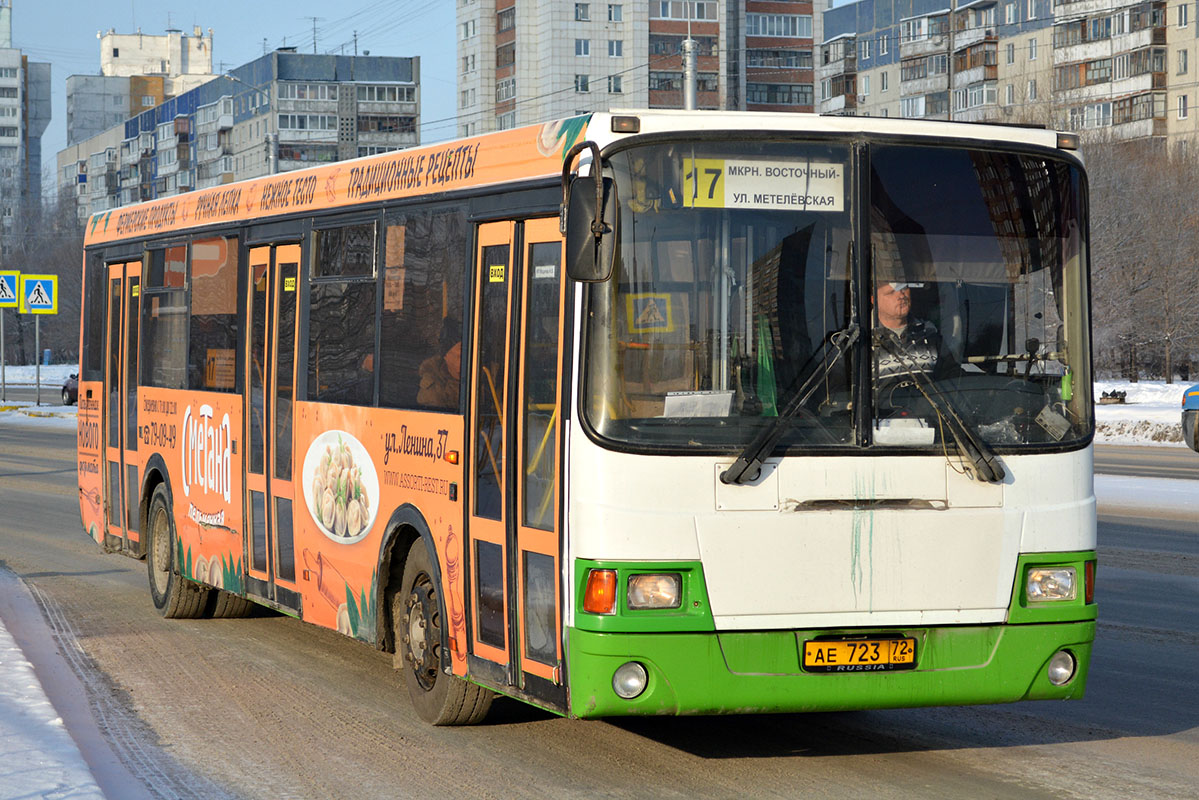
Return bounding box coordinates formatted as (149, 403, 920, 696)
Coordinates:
(0, 427, 1199, 800)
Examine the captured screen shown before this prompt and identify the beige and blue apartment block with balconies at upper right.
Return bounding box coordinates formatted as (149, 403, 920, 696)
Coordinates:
(817, 0, 1199, 146)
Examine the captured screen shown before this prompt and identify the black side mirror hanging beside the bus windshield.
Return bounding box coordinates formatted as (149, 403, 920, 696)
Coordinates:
(566, 175, 620, 283)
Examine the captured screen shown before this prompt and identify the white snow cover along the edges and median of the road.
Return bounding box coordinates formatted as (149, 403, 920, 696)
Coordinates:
(0, 365, 1199, 799)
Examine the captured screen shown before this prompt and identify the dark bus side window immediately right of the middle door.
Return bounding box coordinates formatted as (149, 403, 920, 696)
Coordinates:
(308, 222, 378, 405)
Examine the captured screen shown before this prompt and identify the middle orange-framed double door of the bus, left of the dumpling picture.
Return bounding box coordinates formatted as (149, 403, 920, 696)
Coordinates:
(243, 245, 301, 610)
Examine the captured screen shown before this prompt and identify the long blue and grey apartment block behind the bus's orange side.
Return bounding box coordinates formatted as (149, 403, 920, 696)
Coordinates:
(58, 48, 420, 218)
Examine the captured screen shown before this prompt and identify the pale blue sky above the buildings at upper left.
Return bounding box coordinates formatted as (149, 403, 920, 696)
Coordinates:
(12, 0, 457, 190)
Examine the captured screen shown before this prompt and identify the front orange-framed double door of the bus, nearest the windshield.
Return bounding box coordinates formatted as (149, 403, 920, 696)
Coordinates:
(468, 218, 566, 708)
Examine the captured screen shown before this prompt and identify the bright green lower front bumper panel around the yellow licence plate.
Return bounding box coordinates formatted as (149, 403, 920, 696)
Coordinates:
(568, 621, 1095, 717)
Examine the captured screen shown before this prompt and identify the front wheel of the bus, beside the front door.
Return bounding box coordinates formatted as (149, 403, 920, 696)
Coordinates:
(391, 539, 495, 726)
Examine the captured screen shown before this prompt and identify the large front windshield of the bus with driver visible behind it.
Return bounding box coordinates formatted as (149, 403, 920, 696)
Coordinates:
(584, 139, 1092, 452)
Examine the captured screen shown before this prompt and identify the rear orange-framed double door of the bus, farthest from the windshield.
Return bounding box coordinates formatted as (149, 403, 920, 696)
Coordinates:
(104, 261, 141, 555)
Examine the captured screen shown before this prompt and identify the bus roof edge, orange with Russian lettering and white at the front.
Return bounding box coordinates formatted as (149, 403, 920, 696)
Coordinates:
(85, 109, 1059, 246)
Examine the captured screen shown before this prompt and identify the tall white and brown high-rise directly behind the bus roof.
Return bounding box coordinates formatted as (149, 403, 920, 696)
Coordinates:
(457, 0, 819, 136)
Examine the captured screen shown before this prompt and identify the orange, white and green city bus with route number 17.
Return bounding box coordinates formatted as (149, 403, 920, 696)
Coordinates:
(78, 110, 1097, 724)
